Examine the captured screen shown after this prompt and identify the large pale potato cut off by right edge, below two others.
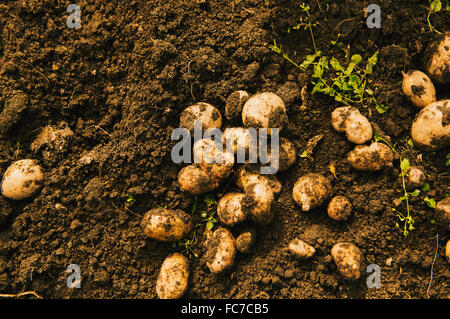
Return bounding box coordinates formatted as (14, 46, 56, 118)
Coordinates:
(411, 100, 450, 151)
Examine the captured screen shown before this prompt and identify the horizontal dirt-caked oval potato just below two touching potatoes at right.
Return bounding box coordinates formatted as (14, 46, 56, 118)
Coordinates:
(347, 142, 394, 172)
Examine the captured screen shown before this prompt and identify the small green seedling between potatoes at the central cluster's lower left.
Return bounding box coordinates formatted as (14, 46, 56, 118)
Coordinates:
(173, 195, 217, 258)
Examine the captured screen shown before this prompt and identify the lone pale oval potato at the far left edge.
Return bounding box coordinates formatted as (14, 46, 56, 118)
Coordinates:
(1, 159, 44, 200)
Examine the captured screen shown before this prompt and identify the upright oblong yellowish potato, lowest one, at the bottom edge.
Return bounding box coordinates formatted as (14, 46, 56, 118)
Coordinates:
(156, 253, 189, 299)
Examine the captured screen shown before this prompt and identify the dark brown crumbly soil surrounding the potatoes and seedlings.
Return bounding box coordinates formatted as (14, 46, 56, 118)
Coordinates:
(0, 0, 450, 298)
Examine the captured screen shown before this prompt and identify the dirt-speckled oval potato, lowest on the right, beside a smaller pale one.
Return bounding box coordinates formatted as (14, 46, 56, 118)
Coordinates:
(331, 243, 362, 280)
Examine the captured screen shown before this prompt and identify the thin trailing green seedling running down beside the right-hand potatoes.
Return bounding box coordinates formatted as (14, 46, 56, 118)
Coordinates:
(374, 134, 420, 237)
